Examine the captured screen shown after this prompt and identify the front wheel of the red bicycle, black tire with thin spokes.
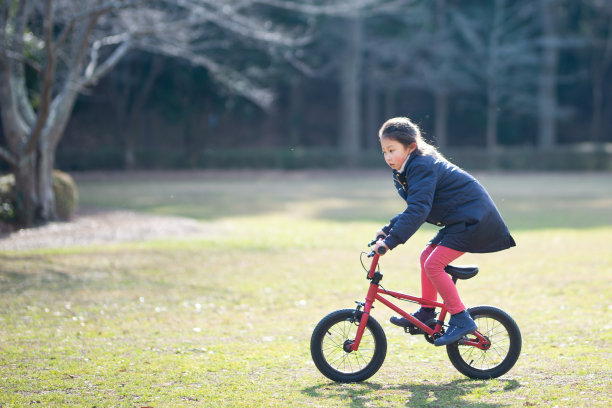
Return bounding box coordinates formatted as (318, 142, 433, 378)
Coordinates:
(310, 309, 387, 383)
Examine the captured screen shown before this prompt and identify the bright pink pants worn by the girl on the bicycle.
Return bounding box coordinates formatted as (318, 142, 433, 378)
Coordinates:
(421, 245, 465, 314)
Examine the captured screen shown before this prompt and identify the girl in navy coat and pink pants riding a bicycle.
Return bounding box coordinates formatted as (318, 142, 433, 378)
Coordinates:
(374, 117, 515, 346)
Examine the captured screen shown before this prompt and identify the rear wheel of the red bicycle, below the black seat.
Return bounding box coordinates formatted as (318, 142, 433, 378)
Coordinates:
(446, 306, 522, 379)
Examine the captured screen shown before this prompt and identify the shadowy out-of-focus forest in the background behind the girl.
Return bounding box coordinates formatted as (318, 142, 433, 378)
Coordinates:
(0, 0, 612, 174)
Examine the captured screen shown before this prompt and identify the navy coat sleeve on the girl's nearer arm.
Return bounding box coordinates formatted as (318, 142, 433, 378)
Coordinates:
(385, 162, 437, 249)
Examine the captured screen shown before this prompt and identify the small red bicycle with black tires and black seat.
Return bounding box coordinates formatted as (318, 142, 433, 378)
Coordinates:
(310, 241, 521, 383)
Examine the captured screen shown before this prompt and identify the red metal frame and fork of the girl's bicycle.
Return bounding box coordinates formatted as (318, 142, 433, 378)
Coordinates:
(351, 254, 490, 351)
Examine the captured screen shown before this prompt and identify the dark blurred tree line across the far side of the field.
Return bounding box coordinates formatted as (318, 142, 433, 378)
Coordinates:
(58, 0, 612, 163)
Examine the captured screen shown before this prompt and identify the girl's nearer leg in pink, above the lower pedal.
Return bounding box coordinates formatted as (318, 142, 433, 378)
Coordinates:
(423, 245, 465, 314)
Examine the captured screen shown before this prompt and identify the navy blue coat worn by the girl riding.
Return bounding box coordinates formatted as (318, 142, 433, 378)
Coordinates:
(383, 150, 515, 253)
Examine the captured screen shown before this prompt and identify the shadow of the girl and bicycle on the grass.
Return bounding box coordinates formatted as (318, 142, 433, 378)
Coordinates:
(302, 379, 521, 408)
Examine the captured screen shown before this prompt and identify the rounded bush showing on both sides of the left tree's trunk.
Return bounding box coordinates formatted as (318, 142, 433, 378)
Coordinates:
(0, 170, 78, 223)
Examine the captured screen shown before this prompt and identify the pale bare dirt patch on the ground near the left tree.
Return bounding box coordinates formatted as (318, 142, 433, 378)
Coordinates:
(0, 209, 210, 251)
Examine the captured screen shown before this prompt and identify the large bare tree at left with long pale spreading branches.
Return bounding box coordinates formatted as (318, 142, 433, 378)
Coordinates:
(0, 0, 375, 226)
